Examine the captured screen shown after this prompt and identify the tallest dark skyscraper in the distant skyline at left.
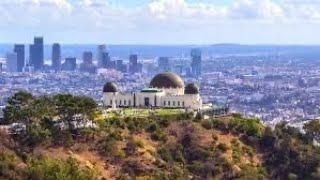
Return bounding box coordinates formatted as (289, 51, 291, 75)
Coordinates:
(29, 37, 44, 71)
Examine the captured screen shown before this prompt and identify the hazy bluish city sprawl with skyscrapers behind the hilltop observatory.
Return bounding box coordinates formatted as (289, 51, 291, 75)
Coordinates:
(0, 37, 320, 123)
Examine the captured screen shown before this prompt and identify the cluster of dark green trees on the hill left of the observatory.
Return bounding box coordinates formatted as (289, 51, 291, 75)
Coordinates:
(4, 91, 97, 145)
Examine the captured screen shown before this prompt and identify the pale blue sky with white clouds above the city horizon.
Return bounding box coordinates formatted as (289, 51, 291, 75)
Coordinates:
(0, 0, 320, 44)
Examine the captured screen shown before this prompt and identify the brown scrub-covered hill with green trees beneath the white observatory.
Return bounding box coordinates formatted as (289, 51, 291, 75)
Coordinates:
(0, 92, 320, 180)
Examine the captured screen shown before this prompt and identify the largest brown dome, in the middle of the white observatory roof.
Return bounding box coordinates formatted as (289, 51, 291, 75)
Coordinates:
(150, 72, 184, 89)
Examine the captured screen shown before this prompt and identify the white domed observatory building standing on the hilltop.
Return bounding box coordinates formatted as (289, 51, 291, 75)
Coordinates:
(103, 72, 202, 110)
